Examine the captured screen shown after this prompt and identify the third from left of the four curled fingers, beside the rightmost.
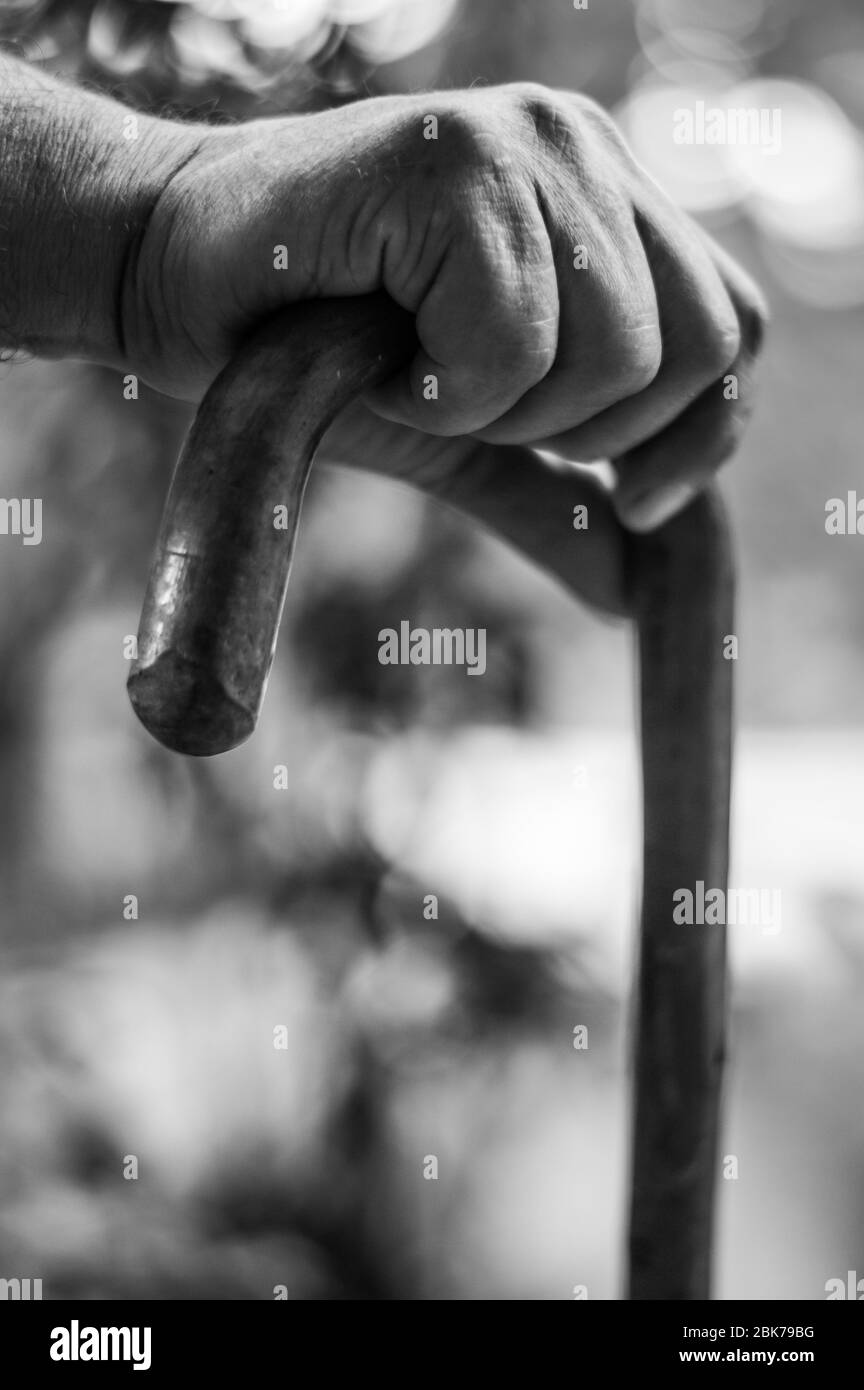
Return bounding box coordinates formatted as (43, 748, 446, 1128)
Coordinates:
(530, 209, 739, 460)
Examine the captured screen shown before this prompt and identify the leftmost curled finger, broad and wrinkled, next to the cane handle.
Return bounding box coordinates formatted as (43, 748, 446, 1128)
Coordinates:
(367, 186, 558, 436)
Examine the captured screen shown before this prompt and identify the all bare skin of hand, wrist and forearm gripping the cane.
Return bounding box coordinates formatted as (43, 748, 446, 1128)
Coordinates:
(0, 58, 765, 607)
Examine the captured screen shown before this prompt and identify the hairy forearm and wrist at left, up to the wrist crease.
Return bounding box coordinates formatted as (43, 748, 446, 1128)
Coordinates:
(0, 58, 206, 367)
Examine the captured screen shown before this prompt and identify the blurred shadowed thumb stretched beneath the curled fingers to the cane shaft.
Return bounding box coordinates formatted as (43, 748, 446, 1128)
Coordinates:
(319, 404, 628, 614)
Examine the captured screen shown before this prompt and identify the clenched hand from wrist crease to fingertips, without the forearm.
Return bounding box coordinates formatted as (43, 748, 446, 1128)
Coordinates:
(122, 85, 765, 530)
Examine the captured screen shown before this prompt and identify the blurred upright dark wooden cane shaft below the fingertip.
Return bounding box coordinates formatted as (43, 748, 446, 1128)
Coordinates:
(629, 492, 733, 1300)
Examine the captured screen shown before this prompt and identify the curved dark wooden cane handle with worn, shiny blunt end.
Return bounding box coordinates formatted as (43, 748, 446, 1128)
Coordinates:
(128, 287, 414, 756)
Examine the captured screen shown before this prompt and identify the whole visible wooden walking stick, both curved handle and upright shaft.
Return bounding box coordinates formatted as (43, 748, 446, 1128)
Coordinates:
(128, 295, 732, 1300)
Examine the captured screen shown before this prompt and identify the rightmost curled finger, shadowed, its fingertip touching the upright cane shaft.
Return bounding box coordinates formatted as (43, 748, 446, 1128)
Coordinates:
(613, 253, 767, 531)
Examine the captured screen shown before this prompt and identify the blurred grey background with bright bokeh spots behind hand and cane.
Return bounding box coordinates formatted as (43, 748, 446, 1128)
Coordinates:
(0, 0, 864, 1300)
